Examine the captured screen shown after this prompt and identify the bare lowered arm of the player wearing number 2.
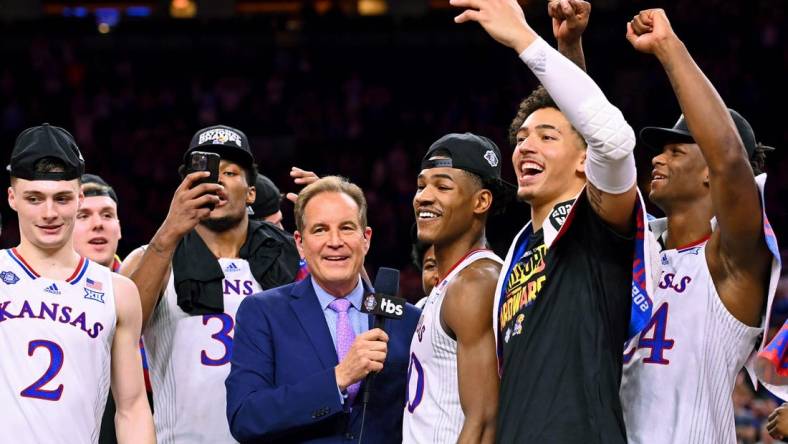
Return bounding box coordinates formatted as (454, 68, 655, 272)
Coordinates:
(111, 275, 156, 444)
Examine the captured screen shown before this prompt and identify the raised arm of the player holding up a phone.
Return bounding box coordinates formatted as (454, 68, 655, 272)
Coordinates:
(120, 171, 223, 326)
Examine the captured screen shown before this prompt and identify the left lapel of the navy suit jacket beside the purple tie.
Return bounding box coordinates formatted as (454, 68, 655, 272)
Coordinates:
(290, 279, 339, 368)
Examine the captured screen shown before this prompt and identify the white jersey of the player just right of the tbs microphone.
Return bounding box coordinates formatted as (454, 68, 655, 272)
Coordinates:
(402, 250, 503, 444)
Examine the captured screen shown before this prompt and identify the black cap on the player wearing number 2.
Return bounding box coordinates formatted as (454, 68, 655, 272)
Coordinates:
(6, 123, 85, 180)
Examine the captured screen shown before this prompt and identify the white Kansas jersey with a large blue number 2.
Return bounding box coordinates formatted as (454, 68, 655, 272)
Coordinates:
(0, 249, 117, 444)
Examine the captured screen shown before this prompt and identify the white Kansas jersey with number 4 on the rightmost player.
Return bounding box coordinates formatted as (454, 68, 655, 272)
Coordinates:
(621, 234, 762, 444)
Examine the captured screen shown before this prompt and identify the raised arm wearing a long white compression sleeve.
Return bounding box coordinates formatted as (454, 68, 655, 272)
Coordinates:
(450, 0, 637, 234)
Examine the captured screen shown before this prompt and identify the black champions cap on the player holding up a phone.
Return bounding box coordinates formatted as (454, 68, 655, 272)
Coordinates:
(183, 125, 254, 169)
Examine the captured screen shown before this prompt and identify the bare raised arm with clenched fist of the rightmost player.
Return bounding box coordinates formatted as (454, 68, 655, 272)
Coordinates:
(627, 9, 771, 325)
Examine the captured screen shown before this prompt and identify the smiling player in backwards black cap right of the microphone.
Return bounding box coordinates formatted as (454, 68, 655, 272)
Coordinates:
(403, 133, 513, 443)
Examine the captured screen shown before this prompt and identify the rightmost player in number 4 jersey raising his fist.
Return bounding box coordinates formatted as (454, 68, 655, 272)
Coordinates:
(621, 9, 779, 444)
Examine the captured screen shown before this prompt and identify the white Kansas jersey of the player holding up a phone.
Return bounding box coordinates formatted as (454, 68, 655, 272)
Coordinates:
(143, 258, 262, 444)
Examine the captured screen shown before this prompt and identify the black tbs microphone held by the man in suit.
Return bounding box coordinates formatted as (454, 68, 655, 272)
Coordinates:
(361, 267, 405, 404)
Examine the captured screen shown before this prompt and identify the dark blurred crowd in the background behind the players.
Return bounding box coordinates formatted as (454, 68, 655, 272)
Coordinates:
(0, 0, 788, 443)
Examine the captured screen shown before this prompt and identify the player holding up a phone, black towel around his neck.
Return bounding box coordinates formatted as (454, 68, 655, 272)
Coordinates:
(121, 125, 299, 444)
